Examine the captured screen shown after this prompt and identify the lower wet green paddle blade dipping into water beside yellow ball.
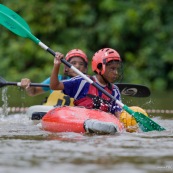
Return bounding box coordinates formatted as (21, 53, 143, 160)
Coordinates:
(123, 105, 166, 132)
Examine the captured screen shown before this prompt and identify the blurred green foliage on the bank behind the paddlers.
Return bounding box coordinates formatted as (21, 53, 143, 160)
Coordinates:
(0, 0, 173, 90)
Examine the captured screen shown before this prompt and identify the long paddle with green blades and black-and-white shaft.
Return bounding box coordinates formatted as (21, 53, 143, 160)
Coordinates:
(0, 4, 165, 132)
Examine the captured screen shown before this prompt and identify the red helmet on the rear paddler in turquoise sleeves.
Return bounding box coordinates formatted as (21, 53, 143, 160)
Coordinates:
(65, 49, 88, 65)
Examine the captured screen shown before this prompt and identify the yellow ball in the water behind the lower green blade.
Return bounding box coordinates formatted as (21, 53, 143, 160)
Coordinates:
(120, 106, 148, 133)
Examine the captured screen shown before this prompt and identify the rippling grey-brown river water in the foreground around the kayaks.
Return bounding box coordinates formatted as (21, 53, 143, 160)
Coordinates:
(0, 88, 173, 173)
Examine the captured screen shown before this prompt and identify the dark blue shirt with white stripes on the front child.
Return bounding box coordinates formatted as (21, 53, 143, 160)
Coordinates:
(62, 76, 122, 113)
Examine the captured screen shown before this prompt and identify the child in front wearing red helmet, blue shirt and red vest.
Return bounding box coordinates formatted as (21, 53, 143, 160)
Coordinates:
(50, 48, 122, 118)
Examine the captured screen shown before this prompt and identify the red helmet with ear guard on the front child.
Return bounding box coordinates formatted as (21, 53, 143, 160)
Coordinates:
(92, 48, 121, 75)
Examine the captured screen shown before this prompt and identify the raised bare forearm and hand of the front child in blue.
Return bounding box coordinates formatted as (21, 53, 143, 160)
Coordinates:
(50, 52, 64, 90)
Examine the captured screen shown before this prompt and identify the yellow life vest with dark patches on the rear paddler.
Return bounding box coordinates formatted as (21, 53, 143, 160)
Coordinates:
(44, 91, 74, 106)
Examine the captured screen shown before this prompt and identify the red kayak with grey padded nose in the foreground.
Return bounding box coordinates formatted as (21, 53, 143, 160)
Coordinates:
(41, 106, 123, 134)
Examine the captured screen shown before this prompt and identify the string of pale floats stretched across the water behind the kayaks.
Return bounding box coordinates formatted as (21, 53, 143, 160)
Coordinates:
(0, 107, 173, 114)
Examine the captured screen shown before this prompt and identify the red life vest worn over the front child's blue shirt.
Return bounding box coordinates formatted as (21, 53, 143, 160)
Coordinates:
(74, 79, 113, 112)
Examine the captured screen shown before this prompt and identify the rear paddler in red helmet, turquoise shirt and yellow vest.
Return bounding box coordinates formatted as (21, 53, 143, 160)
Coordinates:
(21, 49, 88, 106)
